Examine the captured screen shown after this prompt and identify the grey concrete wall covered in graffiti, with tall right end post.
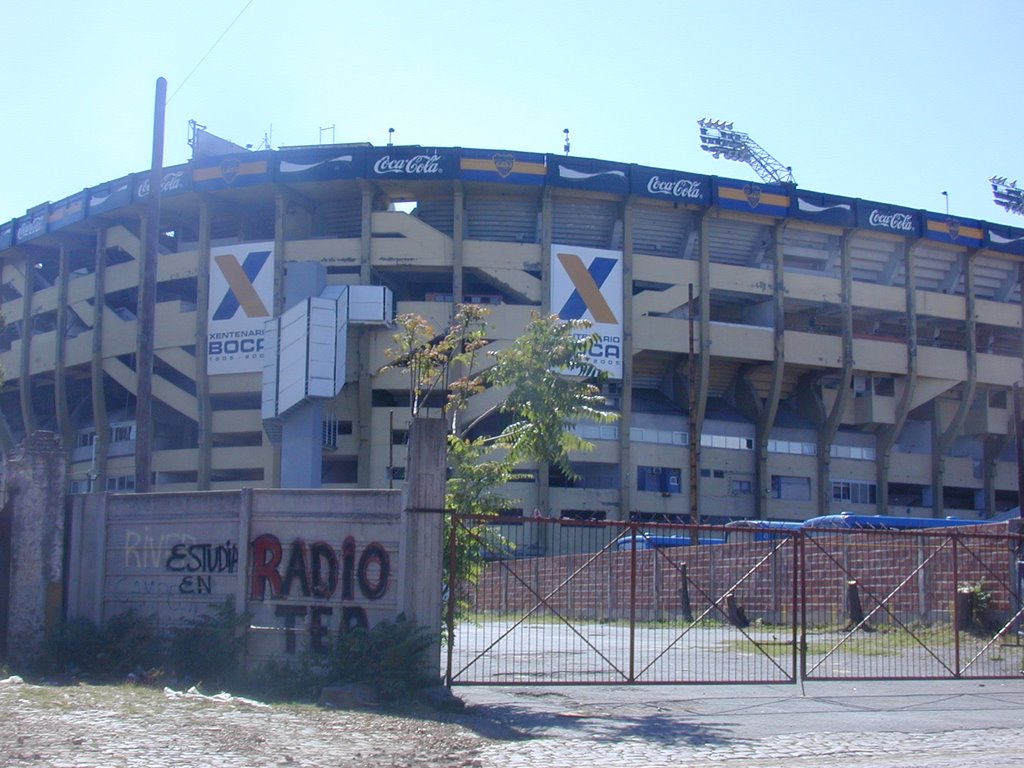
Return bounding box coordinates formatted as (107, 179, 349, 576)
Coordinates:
(60, 422, 444, 665)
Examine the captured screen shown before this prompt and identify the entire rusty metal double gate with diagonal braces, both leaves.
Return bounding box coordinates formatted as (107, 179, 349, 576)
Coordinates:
(445, 515, 1024, 685)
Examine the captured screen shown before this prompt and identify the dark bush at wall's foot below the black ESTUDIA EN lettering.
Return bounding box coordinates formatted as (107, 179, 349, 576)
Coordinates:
(169, 598, 251, 686)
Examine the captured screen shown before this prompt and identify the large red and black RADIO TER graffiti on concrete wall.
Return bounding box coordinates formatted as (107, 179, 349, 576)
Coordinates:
(249, 534, 391, 653)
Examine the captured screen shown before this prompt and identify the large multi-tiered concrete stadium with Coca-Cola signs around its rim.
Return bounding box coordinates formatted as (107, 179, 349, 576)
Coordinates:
(0, 138, 1024, 523)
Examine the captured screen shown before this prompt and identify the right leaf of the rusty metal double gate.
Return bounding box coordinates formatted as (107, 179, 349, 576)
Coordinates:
(801, 528, 1024, 680)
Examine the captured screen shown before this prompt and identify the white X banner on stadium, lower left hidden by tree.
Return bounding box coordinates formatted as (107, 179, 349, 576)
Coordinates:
(551, 245, 623, 379)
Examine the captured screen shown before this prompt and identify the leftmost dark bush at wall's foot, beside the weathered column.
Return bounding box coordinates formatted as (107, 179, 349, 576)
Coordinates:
(42, 610, 164, 678)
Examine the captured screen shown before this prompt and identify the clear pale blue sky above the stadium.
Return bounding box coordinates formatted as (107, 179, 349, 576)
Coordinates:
(6, 0, 1024, 227)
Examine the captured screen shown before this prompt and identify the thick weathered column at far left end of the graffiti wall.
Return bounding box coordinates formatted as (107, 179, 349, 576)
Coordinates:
(3, 432, 68, 669)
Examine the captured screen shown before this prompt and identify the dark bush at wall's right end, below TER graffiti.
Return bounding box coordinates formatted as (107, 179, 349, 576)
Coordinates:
(331, 615, 437, 703)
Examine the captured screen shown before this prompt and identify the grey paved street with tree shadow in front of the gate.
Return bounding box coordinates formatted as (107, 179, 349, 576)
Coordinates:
(457, 681, 1024, 768)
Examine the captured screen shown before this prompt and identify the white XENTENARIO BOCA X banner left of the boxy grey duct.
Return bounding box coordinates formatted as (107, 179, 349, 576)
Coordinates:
(207, 243, 273, 375)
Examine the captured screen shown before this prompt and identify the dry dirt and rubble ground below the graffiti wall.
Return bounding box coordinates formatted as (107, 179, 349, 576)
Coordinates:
(0, 678, 488, 768)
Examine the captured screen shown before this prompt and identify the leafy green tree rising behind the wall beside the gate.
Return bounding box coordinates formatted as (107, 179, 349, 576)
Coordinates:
(382, 304, 617, 593)
